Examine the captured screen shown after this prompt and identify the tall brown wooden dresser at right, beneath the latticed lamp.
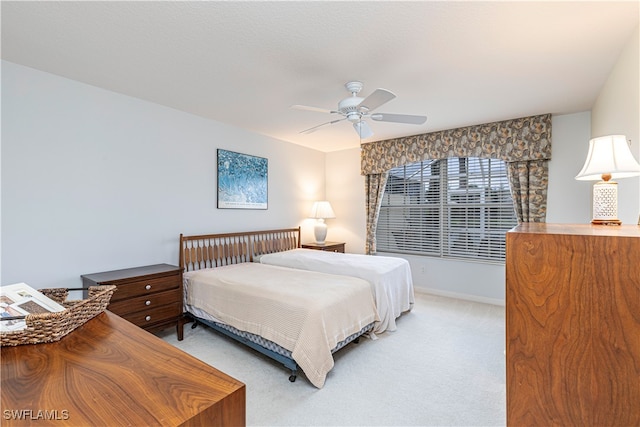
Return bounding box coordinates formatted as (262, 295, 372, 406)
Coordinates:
(506, 224, 640, 426)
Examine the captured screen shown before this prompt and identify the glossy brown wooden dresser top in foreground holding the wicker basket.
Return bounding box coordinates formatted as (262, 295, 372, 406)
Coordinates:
(0, 311, 246, 427)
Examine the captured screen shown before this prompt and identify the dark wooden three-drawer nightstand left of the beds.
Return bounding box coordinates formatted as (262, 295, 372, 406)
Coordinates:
(81, 264, 184, 341)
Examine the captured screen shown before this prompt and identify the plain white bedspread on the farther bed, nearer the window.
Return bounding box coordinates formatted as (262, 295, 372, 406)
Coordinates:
(260, 249, 415, 333)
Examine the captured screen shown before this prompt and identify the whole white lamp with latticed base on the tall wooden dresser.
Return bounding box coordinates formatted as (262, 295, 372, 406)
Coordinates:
(576, 135, 640, 225)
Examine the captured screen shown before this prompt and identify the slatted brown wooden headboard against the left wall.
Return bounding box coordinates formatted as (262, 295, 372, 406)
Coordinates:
(180, 227, 301, 271)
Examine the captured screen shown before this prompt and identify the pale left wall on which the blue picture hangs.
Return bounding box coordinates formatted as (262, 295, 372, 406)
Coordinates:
(0, 61, 325, 288)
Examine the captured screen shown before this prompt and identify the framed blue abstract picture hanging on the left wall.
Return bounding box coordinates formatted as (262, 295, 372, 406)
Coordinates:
(218, 149, 269, 209)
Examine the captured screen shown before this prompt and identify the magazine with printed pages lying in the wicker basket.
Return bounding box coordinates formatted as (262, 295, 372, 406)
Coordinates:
(0, 283, 65, 332)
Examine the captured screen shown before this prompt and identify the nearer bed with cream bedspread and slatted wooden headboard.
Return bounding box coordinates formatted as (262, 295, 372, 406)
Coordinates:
(180, 230, 379, 388)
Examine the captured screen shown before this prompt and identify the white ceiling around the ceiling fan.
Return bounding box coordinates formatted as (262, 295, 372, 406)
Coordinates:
(1, 0, 640, 152)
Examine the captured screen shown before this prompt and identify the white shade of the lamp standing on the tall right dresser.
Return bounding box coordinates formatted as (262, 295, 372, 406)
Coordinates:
(576, 135, 640, 181)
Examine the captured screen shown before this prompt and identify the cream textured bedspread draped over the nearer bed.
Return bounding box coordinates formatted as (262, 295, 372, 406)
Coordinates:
(184, 263, 378, 388)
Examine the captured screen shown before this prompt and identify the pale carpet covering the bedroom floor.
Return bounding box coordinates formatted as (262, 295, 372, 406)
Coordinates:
(161, 294, 506, 426)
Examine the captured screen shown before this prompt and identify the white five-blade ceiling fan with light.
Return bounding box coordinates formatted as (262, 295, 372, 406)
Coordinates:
(291, 81, 427, 138)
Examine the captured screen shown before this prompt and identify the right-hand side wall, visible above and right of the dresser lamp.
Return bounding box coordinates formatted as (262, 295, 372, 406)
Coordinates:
(585, 28, 640, 224)
